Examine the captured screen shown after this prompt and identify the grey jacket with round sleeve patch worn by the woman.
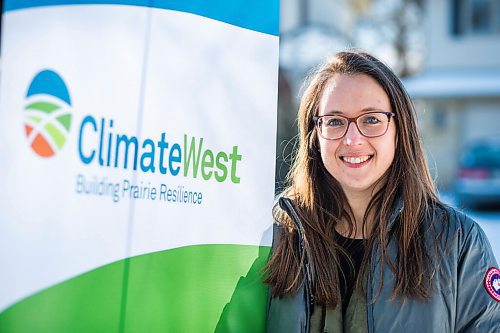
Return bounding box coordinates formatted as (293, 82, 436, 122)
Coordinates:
(266, 199, 500, 333)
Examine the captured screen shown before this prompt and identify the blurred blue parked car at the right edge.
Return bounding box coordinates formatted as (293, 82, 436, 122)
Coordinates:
(455, 138, 500, 209)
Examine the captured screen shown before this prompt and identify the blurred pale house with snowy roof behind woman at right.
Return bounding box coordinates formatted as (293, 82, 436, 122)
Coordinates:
(404, 0, 500, 190)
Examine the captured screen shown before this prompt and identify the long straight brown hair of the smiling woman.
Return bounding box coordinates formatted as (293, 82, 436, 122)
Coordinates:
(266, 50, 450, 307)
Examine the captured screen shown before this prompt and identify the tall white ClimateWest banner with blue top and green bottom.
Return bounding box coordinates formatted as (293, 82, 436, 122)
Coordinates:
(0, 0, 279, 332)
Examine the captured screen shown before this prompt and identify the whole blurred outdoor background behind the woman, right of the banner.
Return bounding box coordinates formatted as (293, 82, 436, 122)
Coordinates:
(0, 0, 500, 253)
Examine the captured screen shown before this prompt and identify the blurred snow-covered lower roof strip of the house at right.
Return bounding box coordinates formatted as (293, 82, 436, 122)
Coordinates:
(402, 68, 500, 98)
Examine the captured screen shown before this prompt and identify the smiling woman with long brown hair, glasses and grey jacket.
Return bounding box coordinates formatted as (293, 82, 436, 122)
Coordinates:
(266, 51, 500, 333)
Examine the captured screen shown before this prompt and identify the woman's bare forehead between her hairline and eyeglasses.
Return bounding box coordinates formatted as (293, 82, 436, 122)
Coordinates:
(319, 74, 391, 116)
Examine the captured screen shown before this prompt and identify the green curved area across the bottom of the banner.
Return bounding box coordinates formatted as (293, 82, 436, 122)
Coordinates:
(0, 245, 270, 333)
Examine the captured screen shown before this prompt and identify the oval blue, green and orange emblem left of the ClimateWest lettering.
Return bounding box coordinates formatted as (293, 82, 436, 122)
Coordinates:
(24, 70, 71, 157)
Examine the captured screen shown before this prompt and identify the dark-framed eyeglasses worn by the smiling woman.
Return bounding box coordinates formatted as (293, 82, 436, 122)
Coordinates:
(313, 112, 396, 140)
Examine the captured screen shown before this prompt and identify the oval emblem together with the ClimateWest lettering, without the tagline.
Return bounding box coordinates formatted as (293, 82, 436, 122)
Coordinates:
(24, 70, 243, 188)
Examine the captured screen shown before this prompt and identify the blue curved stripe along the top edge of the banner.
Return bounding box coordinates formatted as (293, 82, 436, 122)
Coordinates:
(3, 0, 279, 36)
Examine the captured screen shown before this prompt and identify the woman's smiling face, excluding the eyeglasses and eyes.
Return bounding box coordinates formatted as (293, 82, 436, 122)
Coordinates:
(318, 74, 396, 196)
